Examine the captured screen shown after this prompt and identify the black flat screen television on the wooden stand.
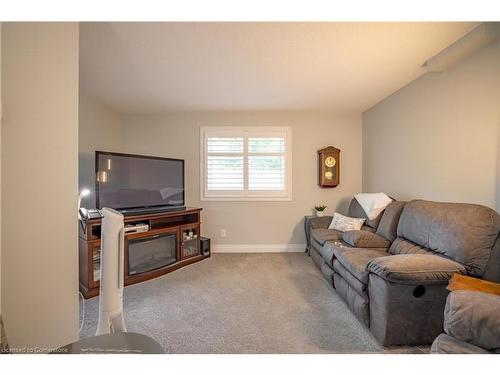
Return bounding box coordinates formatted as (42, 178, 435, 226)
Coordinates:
(95, 151, 185, 214)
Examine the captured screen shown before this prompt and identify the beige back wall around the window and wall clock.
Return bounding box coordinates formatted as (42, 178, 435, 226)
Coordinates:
(120, 112, 362, 251)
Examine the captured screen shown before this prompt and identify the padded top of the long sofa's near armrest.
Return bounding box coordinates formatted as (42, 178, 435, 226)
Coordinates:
(367, 254, 465, 284)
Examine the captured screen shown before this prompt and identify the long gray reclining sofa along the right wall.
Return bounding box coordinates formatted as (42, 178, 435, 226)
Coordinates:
(308, 199, 500, 346)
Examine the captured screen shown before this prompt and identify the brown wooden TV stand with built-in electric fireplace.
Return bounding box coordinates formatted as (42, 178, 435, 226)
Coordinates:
(79, 208, 207, 298)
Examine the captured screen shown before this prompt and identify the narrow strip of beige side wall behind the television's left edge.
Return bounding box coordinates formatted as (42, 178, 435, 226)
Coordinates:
(78, 93, 123, 208)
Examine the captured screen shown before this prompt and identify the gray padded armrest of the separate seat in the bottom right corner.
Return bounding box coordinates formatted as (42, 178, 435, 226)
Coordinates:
(444, 290, 500, 350)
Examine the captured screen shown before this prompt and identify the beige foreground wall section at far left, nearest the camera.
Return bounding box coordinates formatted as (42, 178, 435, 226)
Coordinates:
(1, 23, 78, 350)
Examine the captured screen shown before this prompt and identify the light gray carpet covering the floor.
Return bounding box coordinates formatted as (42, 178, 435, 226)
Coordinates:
(82, 253, 428, 353)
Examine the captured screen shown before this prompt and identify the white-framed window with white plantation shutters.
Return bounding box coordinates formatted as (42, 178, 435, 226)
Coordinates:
(200, 126, 292, 200)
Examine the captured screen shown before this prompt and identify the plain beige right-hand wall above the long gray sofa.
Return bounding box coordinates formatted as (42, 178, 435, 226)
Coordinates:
(363, 42, 500, 210)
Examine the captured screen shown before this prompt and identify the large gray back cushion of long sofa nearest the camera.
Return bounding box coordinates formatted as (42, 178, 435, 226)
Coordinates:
(397, 200, 500, 276)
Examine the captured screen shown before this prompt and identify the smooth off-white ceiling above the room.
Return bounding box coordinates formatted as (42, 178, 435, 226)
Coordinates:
(80, 22, 477, 113)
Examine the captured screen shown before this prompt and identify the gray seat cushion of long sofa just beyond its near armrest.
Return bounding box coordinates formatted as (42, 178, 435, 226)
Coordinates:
(333, 244, 389, 284)
